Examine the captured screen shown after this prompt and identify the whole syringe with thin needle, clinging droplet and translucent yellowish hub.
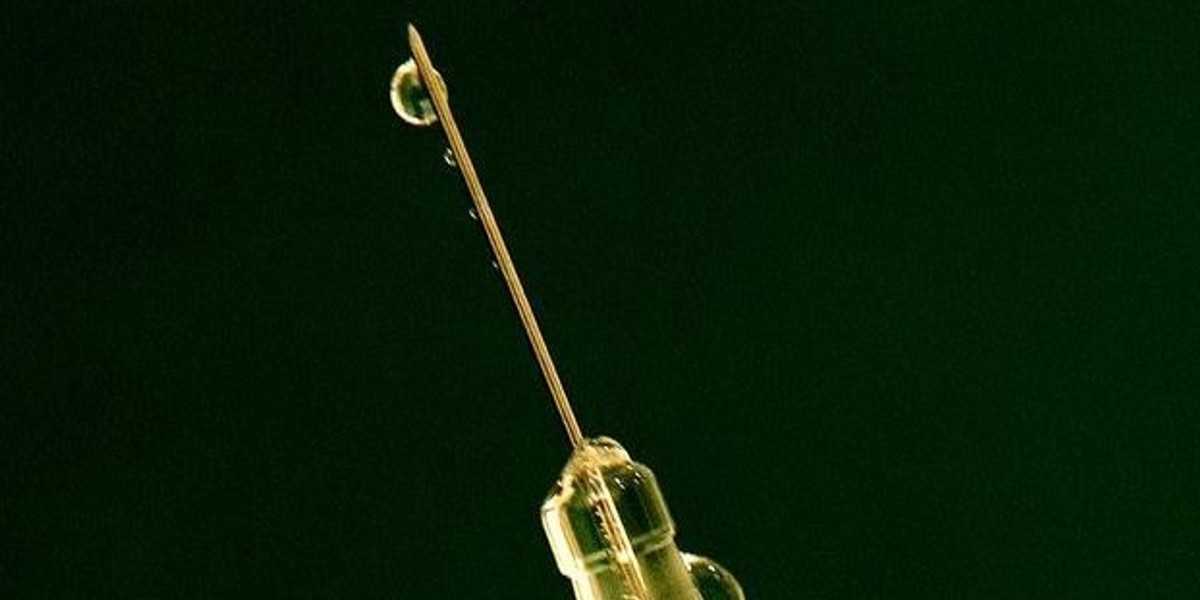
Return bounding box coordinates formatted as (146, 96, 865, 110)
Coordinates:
(391, 25, 744, 600)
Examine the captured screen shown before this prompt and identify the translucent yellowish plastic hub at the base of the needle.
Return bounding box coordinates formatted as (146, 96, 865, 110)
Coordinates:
(541, 438, 743, 600)
